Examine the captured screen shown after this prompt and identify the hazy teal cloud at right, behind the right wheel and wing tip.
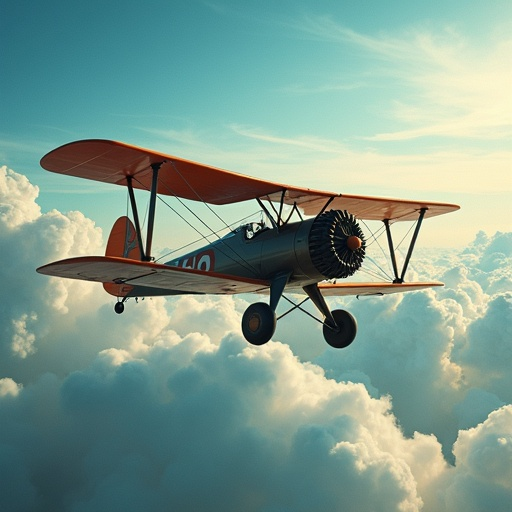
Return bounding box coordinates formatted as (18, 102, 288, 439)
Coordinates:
(316, 233, 512, 461)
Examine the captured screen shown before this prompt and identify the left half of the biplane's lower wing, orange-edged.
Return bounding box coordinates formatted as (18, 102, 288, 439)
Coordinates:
(37, 256, 270, 296)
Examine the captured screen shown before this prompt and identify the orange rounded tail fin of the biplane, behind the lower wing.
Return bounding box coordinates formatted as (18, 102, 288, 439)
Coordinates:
(103, 216, 142, 297)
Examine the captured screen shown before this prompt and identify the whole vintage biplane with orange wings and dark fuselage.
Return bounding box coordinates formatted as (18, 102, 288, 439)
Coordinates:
(37, 140, 459, 348)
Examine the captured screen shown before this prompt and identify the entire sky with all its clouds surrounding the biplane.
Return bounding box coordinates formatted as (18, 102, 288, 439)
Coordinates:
(0, 0, 512, 512)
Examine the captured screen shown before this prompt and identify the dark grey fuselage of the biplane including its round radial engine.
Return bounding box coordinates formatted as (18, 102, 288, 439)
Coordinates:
(167, 210, 365, 287)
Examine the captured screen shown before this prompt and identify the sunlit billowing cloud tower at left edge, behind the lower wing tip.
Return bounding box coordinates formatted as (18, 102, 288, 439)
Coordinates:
(0, 167, 104, 376)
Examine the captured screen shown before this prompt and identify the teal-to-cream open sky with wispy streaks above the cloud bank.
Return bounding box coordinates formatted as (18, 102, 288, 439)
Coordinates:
(0, 1, 512, 246)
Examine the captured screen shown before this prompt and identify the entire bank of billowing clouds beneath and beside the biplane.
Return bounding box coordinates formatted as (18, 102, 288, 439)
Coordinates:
(0, 166, 512, 512)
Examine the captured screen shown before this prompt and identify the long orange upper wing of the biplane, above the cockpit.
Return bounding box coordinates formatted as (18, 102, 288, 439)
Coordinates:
(41, 140, 459, 220)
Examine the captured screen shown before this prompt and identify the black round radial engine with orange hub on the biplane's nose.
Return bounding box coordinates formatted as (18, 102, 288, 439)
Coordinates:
(308, 210, 366, 279)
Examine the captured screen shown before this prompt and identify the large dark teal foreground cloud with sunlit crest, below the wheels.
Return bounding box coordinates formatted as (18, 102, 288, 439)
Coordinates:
(0, 336, 436, 510)
